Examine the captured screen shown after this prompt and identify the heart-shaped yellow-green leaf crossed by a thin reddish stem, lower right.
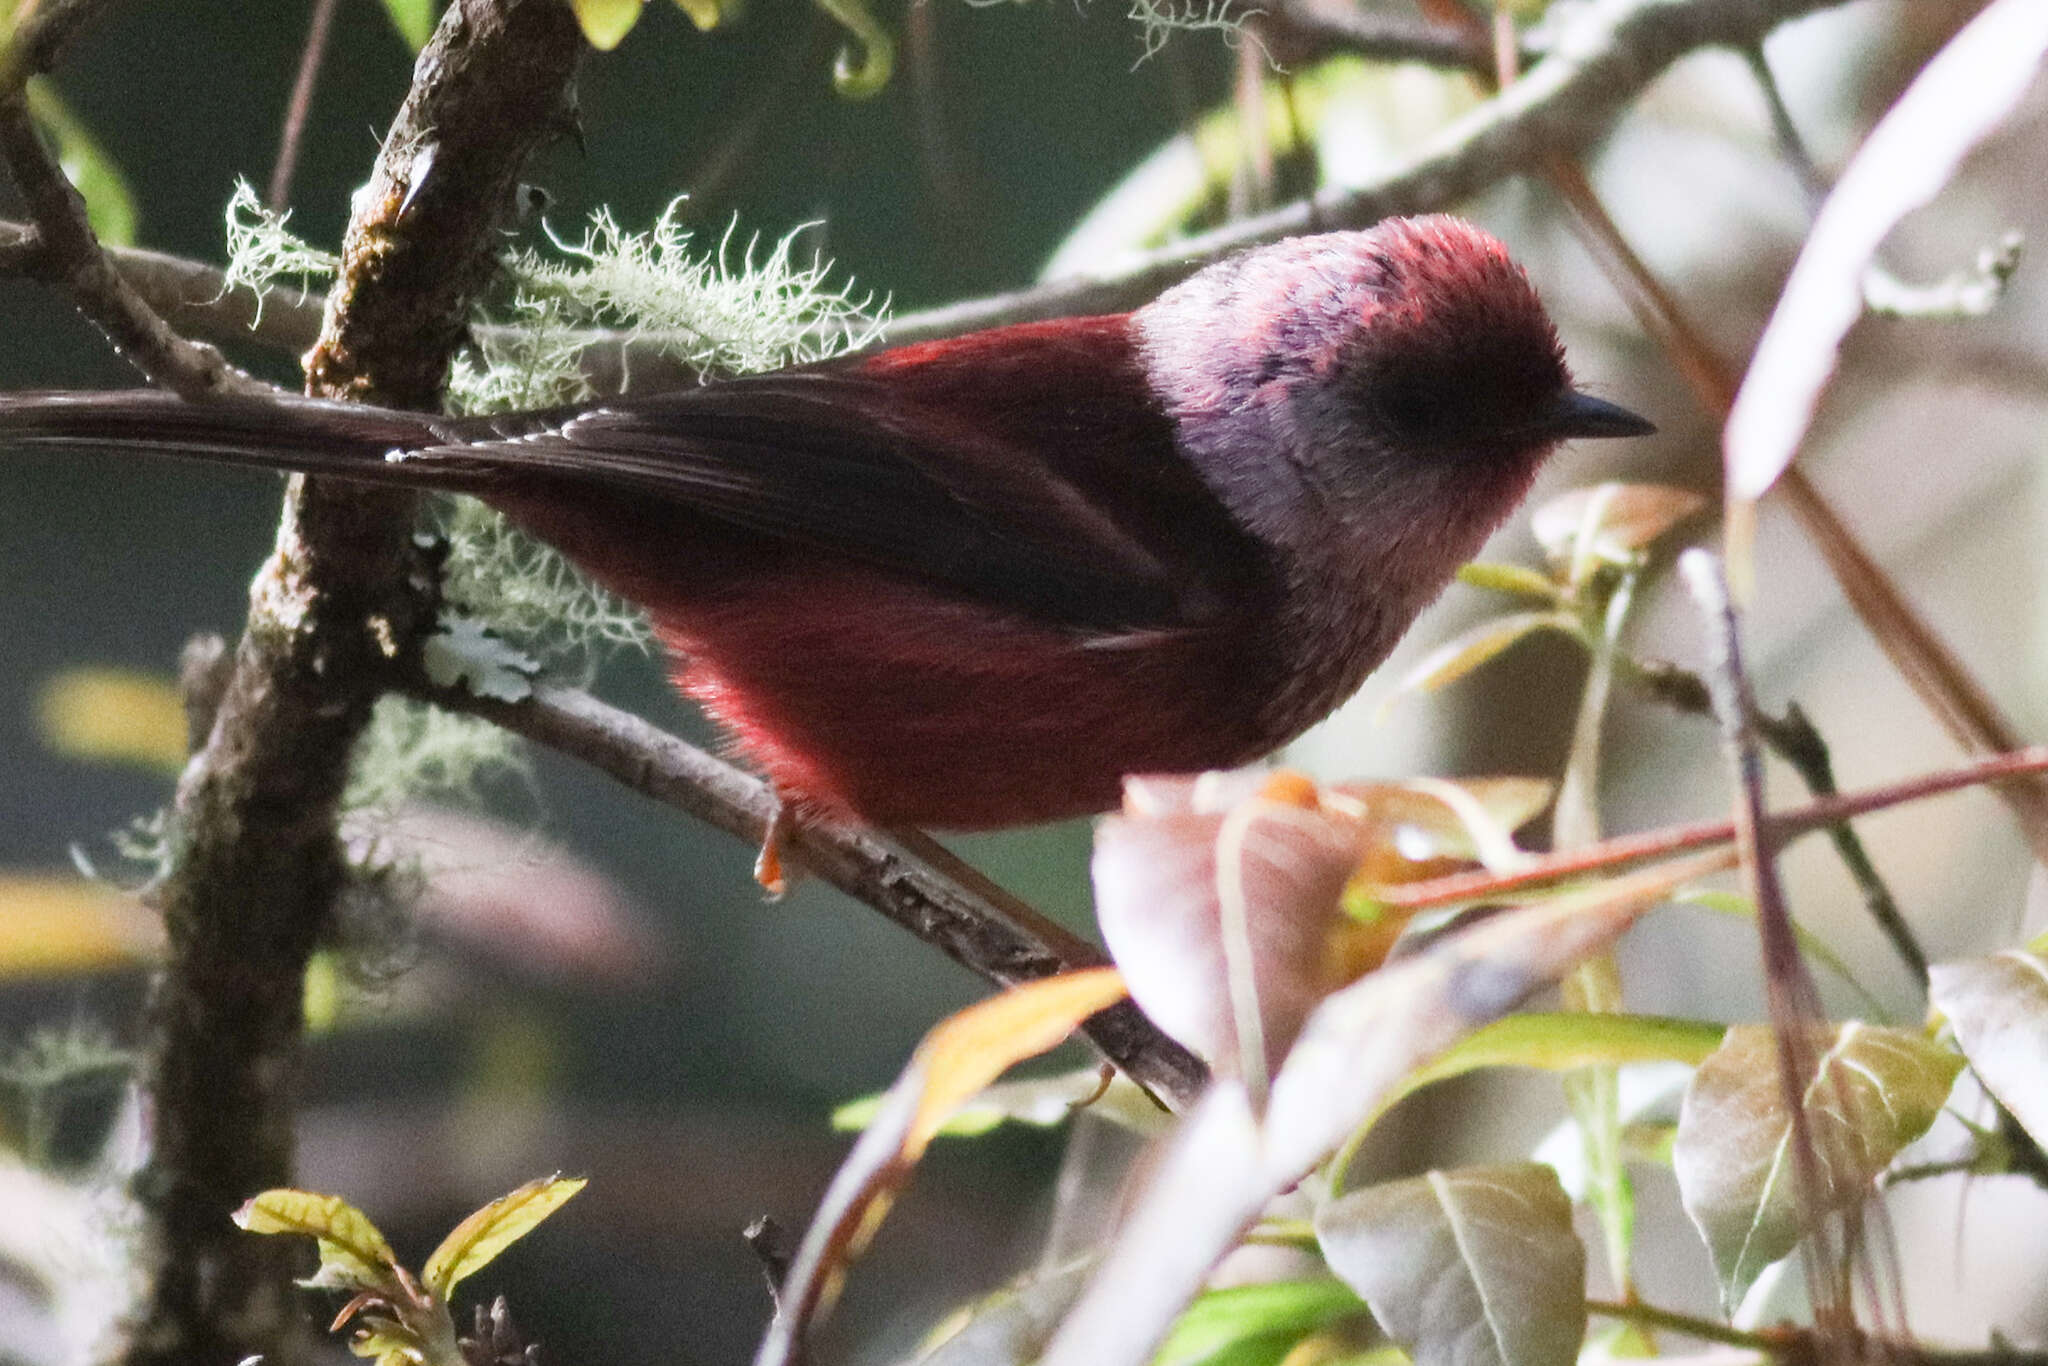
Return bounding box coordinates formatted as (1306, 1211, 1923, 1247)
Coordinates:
(1671, 1022, 1962, 1311)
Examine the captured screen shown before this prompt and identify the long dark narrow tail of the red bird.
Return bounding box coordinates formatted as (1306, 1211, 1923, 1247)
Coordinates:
(0, 389, 505, 492)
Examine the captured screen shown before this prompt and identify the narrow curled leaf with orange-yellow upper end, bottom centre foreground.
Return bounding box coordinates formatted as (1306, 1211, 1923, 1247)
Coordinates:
(756, 969, 1126, 1366)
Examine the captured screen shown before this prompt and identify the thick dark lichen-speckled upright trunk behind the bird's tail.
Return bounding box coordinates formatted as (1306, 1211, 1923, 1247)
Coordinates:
(115, 0, 582, 1366)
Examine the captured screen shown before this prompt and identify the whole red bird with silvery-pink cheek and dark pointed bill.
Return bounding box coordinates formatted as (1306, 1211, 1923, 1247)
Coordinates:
(0, 215, 1655, 829)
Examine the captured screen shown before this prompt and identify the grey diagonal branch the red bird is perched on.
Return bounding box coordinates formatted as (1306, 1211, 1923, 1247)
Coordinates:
(408, 680, 1206, 1106)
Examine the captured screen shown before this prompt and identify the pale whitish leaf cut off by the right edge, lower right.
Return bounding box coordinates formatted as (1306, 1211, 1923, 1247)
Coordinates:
(1927, 948, 2048, 1145)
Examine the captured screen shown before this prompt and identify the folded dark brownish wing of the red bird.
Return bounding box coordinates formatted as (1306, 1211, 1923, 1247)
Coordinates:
(423, 367, 1221, 631)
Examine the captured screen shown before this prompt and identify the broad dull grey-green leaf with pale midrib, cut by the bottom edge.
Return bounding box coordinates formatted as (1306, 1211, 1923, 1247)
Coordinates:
(1315, 1163, 1585, 1366)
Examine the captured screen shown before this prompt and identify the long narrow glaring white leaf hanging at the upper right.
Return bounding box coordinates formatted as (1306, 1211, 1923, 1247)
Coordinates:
(1722, 0, 2048, 518)
